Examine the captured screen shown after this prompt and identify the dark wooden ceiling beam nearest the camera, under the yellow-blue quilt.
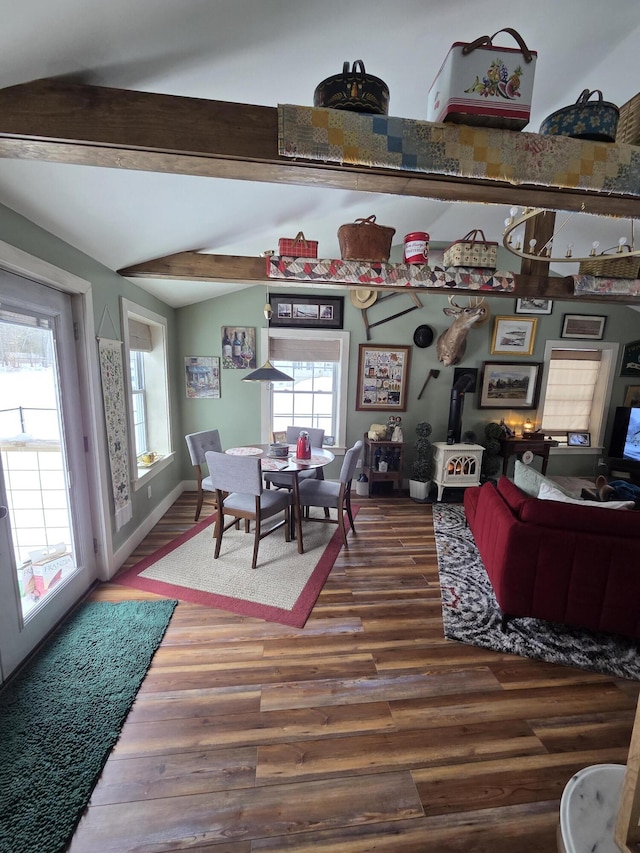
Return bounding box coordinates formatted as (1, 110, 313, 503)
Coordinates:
(0, 78, 640, 218)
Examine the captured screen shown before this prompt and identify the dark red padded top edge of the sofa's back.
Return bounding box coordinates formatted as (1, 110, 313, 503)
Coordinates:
(520, 482, 640, 540)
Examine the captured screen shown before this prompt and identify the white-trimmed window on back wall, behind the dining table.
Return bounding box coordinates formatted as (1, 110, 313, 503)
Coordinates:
(263, 329, 349, 447)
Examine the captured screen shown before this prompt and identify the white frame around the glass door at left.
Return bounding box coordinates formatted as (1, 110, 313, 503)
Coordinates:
(0, 240, 113, 581)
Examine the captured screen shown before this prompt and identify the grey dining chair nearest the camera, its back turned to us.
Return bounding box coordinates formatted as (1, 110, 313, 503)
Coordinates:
(206, 450, 291, 569)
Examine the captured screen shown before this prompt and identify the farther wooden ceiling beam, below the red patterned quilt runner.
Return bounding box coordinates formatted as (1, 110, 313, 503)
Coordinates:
(118, 252, 633, 304)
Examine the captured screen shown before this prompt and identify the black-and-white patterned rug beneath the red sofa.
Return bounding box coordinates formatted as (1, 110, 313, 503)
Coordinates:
(433, 504, 640, 681)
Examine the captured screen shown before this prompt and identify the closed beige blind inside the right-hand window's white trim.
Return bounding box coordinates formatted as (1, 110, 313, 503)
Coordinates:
(542, 349, 601, 434)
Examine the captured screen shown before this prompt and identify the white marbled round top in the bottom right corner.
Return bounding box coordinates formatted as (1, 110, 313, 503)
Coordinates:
(558, 764, 626, 853)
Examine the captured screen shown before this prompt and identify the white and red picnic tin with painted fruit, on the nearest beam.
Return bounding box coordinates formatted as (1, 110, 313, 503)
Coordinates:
(427, 27, 537, 130)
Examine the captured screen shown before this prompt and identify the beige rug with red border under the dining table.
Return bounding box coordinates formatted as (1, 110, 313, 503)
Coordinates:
(113, 507, 357, 628)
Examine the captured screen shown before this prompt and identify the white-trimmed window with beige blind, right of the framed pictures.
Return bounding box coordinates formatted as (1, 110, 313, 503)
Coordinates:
(540, 341, 618, 448)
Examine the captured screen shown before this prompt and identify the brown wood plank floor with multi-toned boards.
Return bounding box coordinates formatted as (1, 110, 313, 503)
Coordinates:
(69, 493, 640, 853)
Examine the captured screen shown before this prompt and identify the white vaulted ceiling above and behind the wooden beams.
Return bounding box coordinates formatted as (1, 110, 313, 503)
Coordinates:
(0, 0, 640, 307)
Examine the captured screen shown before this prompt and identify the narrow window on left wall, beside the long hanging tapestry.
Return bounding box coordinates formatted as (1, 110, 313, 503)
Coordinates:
(121, 299, 171, 488)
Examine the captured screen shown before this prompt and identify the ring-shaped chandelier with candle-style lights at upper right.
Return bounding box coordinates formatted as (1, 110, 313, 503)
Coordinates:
(502, 206, 640, 264)
